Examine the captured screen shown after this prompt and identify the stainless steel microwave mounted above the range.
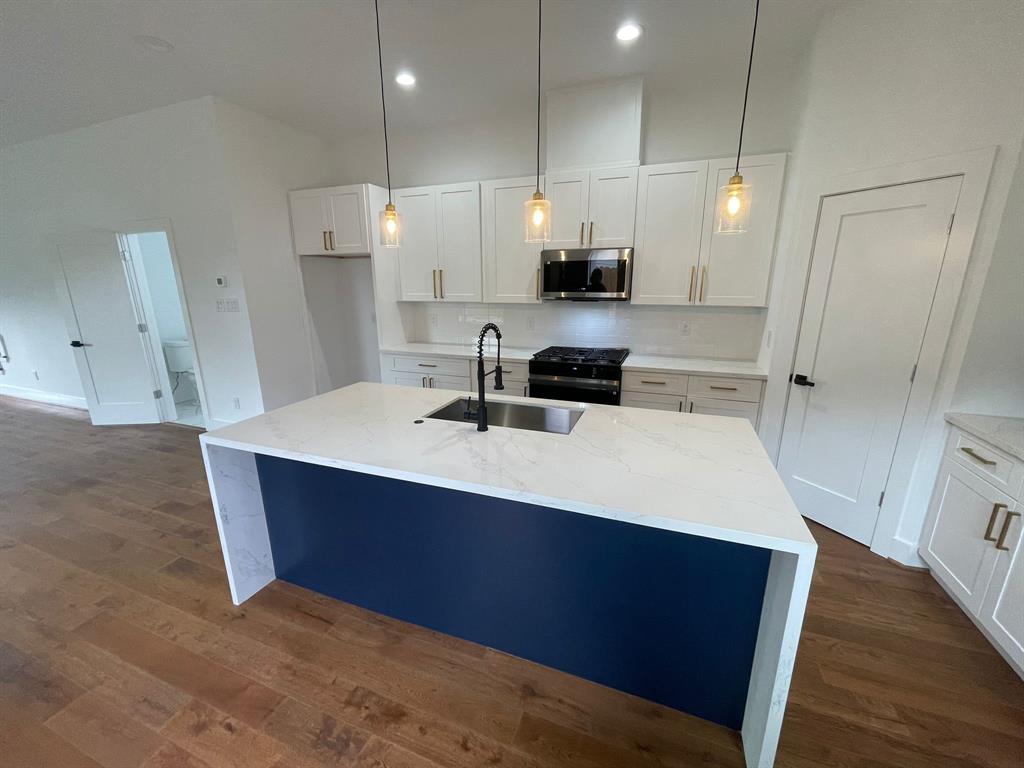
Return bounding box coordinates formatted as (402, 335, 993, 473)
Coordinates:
(541, 248, 633, 301)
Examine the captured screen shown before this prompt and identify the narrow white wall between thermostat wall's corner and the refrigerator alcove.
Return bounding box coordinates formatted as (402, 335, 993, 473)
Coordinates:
(214, 99, 335, 411)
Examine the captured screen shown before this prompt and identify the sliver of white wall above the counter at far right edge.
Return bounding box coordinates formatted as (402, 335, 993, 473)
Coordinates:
(952, 156, 1024, 417)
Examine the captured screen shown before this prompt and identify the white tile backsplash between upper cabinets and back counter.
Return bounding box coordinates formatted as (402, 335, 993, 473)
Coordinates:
(399, 302, 765, 359)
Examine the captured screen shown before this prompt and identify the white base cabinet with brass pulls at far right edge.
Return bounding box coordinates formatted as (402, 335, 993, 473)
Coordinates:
(920, 429, 1024, 677)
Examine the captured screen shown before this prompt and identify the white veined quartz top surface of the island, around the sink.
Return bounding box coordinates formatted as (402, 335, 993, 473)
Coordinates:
(200, 382, 816, 553)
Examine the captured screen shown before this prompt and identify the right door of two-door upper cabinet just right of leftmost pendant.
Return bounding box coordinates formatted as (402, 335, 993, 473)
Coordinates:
(435, 181, 483, 301)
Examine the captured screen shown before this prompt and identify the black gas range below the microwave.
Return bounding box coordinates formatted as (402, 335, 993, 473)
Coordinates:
(529, 347, 630, 406)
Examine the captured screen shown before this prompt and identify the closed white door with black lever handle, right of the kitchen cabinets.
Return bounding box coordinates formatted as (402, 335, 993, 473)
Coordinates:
(779, 176, 962, 544)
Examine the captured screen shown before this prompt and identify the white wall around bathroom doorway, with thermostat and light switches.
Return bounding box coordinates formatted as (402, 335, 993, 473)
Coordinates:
(0, 98, 264, 423)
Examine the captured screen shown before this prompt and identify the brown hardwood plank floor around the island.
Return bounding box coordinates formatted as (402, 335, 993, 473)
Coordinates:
(0, 397, 1024, 768)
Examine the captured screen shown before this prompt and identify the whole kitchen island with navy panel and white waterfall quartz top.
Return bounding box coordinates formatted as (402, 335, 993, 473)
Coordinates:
(201, 383, 816, 766)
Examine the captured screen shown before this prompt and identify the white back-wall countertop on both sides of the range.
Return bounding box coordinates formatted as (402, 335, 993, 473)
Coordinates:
(381, 337, 768, 379)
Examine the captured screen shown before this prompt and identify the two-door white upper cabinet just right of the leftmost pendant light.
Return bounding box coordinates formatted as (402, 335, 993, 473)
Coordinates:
(394, 181, 482, 301)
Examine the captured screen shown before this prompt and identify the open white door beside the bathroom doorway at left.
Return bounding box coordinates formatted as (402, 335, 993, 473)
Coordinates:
(57, 232, 161, 424)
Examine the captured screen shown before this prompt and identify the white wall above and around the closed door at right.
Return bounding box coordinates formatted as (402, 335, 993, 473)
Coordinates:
(761, 0, 1024, 557)
